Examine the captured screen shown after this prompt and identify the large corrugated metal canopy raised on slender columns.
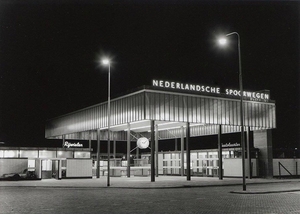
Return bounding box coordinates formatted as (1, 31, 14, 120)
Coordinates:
(45, 85, 276, 140)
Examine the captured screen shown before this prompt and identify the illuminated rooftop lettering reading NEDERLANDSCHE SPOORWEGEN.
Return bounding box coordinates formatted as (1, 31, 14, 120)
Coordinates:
(152, 80, 270, 102)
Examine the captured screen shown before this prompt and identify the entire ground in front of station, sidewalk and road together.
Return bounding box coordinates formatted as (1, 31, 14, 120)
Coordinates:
(0, 177, 300, 214)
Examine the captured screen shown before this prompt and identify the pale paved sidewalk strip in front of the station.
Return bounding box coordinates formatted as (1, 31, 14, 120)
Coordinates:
(0, 176, 300, 194)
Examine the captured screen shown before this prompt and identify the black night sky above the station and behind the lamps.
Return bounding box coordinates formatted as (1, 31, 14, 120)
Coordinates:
(0, 0, 300, 148)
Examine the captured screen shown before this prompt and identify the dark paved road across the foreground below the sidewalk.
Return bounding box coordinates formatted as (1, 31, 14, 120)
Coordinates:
(0, 184, 300, 214)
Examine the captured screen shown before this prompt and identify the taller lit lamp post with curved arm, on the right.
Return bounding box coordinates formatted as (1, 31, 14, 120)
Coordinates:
(219, 32, 246, 191)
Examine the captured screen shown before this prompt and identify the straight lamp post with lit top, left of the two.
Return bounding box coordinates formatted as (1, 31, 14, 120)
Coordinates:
(102, 59, 110, 186)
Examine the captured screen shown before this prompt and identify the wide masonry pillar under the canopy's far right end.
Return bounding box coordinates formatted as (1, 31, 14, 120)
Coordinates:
(253, 129, 273, 178)
